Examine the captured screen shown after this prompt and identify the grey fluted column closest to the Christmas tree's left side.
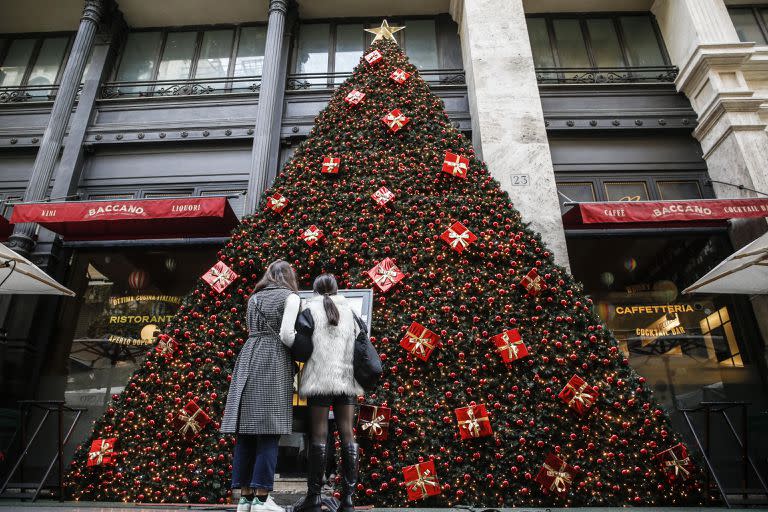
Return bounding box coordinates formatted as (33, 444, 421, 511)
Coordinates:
(245, 0, 288, 214)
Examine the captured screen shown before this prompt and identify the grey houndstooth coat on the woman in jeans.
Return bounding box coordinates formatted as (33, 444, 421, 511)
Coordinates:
(220, 286, 293, 434)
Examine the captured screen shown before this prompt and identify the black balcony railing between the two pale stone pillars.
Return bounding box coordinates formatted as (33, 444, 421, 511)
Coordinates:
(536, 66, 678, 84)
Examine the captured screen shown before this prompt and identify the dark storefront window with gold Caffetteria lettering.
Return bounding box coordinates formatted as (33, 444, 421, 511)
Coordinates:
(568, 235, 762, 407)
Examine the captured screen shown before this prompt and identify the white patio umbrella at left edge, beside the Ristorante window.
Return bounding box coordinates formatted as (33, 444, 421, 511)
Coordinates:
(0, 244, 75, 297)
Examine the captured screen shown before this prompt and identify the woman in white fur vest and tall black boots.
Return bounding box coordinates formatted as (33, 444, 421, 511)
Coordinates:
(294, 274, 363, 512)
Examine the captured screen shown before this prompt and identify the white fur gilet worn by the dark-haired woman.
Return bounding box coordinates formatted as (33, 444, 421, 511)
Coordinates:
(299, 295, 364, 397)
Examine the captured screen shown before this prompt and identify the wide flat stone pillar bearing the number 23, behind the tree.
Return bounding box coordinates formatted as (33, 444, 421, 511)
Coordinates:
(451, 0, 568, 268)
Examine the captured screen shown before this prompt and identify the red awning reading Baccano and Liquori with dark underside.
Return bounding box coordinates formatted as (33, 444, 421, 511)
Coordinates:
(11, 197, 238, 240)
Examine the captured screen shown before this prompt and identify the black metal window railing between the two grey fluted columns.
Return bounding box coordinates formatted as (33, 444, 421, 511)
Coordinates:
(100, 76, 261, 99)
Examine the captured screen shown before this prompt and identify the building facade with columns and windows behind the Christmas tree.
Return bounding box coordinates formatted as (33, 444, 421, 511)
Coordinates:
(0, 0, 768, 490)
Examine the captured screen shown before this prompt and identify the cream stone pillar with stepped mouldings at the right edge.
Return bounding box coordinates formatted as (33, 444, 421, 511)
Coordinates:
(651, 0, 768, 359)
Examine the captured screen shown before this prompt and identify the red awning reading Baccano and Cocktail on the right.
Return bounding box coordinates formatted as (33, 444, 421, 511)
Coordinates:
(563, 199, 768, 227)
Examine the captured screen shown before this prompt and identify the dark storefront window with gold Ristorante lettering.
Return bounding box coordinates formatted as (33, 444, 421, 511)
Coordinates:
(60, 246, 218, 435)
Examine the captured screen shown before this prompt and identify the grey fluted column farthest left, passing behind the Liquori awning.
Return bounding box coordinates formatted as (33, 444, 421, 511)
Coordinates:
(9, 0, 105, 255)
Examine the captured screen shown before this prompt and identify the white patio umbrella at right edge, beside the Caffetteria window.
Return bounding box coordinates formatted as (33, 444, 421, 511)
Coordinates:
(683, 233, 768, 295)
